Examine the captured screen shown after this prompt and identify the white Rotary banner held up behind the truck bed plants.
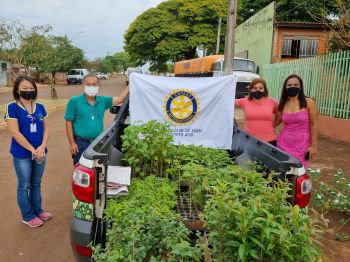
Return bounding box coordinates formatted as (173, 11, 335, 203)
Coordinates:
(130, 73, 236, 149)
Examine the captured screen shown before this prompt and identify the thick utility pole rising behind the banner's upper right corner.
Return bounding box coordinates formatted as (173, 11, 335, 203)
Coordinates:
(224, 0, 238, 75)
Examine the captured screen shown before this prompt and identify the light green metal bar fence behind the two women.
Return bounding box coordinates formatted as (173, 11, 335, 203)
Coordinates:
(261, 51, 350, 119)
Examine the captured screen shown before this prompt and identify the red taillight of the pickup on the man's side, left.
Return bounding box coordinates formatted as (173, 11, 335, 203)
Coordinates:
(72, 164, 95, 203)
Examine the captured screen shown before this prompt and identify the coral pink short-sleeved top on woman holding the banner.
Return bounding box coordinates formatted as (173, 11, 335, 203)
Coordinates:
(236, 97, 278, 142)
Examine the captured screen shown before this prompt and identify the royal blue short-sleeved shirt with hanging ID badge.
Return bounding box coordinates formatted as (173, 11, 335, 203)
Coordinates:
(4, 101, 47, 158)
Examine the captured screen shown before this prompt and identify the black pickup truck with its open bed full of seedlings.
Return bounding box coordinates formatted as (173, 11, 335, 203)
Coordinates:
(70, 99, 312, 261)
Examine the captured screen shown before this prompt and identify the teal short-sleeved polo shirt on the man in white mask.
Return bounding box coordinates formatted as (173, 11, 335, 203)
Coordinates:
(64, 94, 113, 139)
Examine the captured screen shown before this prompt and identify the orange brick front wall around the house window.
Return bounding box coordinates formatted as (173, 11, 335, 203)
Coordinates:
(271, 27, 328, 63)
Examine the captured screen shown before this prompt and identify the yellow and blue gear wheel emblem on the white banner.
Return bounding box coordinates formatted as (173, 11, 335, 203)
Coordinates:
(164, 89, 199, 125)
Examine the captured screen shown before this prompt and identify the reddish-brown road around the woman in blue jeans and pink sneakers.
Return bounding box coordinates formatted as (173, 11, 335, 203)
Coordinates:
(0, 78, 125, 262)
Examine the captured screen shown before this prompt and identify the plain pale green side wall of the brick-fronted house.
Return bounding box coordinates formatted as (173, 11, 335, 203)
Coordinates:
(235, 2, 275, 66)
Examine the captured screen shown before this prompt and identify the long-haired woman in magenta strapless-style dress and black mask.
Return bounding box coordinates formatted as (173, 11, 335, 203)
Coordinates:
(275, 75, 318, 168)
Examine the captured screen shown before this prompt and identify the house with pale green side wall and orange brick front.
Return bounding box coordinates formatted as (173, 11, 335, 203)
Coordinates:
(235, 2, 329, 66)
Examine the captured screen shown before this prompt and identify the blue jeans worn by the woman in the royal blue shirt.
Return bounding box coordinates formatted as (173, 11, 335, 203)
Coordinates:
(13, 157, 46, 221)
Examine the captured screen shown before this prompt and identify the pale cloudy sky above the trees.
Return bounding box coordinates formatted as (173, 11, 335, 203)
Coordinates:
(0, 0, 164, 60)
